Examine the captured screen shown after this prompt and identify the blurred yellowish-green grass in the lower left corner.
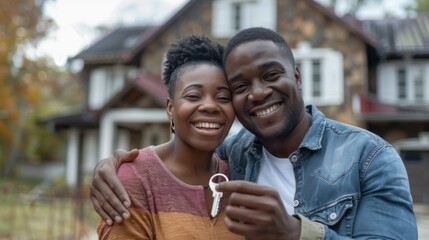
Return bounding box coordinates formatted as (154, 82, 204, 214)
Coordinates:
(0, 179, 99, 240)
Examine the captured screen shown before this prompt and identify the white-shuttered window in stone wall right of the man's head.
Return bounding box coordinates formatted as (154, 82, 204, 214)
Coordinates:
(293, 42, 344, 106)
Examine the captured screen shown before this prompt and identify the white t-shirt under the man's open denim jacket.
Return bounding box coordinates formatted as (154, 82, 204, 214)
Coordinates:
(257, 148, 296, 214)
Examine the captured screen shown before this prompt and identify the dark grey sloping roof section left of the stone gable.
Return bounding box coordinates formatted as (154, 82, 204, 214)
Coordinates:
(73, 26, 157, 63)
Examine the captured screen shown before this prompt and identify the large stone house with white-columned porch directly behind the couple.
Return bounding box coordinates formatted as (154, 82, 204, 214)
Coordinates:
(41, 0, 429, 202)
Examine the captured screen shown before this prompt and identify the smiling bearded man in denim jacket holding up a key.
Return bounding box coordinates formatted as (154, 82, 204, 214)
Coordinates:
(91, 28, 417, 239)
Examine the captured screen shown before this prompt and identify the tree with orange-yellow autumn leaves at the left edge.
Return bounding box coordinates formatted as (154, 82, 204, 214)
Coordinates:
(0, 0, 81, 175)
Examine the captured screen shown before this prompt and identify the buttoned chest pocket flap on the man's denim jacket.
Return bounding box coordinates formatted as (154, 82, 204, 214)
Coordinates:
(308, 197, 353, 227)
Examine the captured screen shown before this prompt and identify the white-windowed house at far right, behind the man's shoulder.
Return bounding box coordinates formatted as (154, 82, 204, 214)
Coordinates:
(358, 15, 429, 203)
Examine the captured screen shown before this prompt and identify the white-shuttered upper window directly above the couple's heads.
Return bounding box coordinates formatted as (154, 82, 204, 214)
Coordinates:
(212, 0, 277, 38)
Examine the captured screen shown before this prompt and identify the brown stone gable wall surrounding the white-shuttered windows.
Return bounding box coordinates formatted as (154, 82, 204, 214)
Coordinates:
(142, 0, 368, 125)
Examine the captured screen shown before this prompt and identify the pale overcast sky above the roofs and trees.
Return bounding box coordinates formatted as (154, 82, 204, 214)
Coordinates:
(36, 0, 413, 66)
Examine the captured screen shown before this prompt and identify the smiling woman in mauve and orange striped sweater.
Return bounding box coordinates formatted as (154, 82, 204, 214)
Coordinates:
(95, 36, 242, 239)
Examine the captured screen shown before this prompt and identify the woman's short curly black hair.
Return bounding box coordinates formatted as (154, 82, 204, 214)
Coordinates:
(163, 35, 224, 98)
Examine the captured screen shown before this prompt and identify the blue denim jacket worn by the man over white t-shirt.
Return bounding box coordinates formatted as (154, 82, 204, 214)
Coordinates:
(218, 106, 417, 240)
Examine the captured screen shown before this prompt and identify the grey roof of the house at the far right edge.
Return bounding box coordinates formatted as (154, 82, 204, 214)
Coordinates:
(361, 15, 429, 55)
